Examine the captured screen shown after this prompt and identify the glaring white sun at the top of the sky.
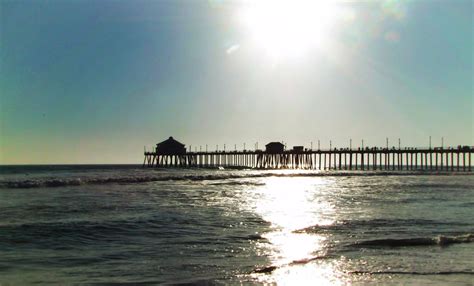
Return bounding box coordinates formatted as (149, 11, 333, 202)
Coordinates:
(240, 0, 340, 59)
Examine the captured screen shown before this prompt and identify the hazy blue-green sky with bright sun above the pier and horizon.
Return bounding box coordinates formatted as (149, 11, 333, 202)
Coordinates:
(0, 0, 474, 164)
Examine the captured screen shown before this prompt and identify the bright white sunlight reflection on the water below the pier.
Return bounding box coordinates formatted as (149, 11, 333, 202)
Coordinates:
(249, 178, 343, 285)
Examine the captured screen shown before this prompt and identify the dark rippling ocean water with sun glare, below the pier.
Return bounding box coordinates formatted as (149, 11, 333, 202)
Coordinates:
(0, 165, 474, 285)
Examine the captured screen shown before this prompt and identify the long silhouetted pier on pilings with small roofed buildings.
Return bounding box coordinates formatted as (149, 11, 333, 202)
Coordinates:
(143, 137, 474, 172)
